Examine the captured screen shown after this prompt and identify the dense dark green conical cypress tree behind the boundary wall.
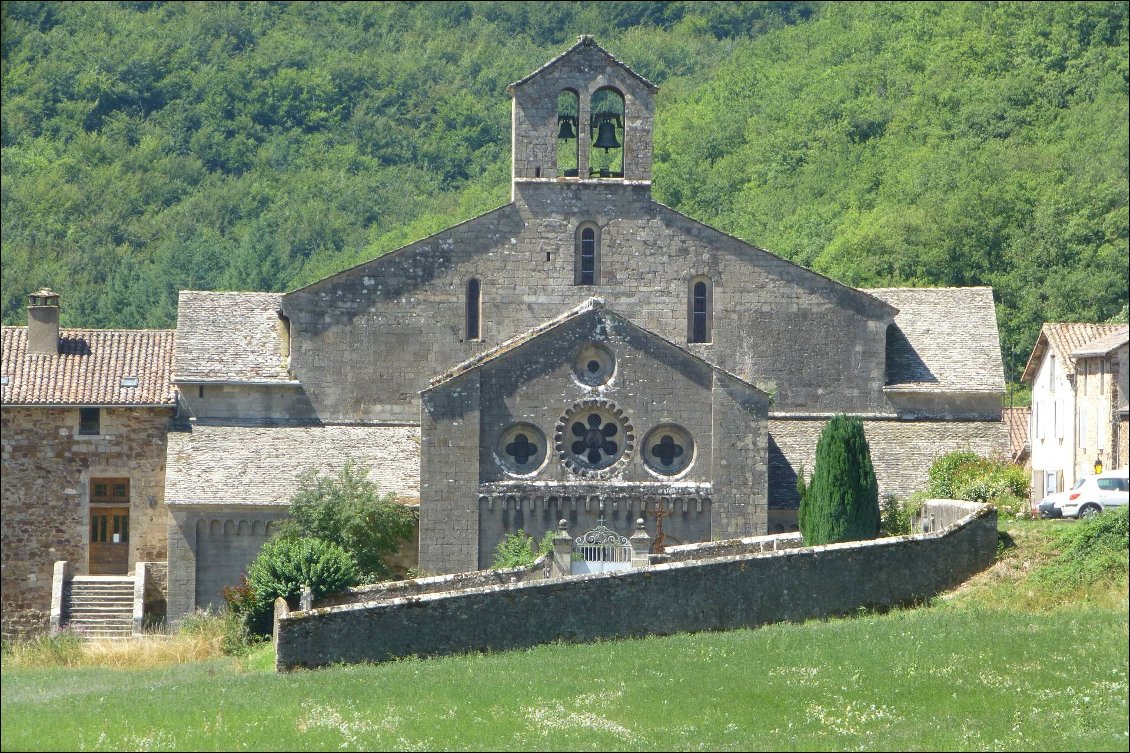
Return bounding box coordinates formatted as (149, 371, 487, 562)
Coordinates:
(799, 415, 879, 546)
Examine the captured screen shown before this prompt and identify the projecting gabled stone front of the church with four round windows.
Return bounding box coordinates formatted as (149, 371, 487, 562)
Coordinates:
(420, 300, 768, 572)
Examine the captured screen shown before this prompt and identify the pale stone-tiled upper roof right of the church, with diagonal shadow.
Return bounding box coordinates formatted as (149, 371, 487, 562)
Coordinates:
(863, 287, 1005, 392)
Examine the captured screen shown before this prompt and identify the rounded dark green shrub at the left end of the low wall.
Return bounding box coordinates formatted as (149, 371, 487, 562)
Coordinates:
(247, 538, 360, 634)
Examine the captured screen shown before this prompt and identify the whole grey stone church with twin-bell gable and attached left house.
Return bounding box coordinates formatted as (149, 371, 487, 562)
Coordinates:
(2, 36, 1008, 630)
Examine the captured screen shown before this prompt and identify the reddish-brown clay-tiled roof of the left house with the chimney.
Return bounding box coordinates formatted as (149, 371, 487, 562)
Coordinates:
(0, 327, 176, 406)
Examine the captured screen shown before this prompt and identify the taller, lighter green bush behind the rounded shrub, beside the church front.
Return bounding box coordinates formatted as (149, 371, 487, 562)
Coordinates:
(279, 461, 418, 576)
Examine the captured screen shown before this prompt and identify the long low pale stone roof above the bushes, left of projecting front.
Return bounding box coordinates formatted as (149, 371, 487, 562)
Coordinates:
(165, 424, 420, 504)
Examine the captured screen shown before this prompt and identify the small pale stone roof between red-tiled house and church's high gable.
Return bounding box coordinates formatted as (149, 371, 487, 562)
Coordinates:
(173, 291, 293, 383)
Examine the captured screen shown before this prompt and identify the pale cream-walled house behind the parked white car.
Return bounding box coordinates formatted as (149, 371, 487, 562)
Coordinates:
(1023, 323, 1130, 501)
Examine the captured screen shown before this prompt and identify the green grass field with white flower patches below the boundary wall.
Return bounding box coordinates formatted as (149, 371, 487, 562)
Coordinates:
(2, 515, 1130, 751)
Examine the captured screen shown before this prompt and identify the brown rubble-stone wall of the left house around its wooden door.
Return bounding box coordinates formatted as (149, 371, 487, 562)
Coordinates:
(0, 406, 173, 634)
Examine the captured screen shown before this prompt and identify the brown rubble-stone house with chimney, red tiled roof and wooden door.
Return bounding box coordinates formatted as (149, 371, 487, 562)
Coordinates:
(0, 291, 176, 634)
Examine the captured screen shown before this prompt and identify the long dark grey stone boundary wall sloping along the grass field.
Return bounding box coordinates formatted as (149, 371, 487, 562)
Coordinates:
(276, 503, 997, 669)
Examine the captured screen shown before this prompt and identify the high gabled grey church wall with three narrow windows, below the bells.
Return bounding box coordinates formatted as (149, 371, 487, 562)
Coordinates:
(283, 182, 893, 422)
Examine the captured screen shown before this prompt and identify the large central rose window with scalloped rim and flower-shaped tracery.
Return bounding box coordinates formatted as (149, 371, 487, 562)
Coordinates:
(554, 400, 635, 476)
